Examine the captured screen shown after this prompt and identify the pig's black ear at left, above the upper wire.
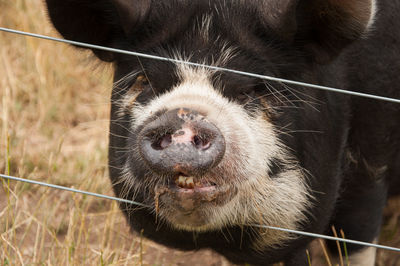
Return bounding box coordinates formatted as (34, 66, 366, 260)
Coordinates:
(46, 0, 151, 61)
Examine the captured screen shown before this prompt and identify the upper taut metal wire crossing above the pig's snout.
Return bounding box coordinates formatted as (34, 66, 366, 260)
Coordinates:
(0, 27, 400, 103)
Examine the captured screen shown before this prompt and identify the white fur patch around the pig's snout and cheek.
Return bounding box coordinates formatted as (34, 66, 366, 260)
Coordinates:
(123, 60, 312, 249)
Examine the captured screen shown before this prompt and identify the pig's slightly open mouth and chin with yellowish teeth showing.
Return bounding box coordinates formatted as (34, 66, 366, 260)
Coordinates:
(154, 174, 237, 227)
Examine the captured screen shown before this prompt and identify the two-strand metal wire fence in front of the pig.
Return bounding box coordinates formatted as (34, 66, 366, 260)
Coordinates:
(0, 27, 400, 252)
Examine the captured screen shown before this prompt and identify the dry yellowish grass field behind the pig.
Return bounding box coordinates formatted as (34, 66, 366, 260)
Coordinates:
(0, 0, 400, 266)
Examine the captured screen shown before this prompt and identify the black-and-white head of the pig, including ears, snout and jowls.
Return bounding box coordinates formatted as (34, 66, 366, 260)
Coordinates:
(47, 0, 375, 258)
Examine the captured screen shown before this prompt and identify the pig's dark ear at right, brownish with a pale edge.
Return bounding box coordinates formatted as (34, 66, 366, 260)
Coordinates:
(259, 0, 376, 63)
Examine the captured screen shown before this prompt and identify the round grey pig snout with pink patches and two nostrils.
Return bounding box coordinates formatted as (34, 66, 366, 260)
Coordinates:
(138, 108, 225, 176)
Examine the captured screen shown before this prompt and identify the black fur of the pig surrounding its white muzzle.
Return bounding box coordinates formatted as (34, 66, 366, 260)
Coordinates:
(46, 0, 400, 265)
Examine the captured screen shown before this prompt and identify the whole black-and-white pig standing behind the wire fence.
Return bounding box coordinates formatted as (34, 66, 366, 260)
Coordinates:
(46, 0, 400, 265)
